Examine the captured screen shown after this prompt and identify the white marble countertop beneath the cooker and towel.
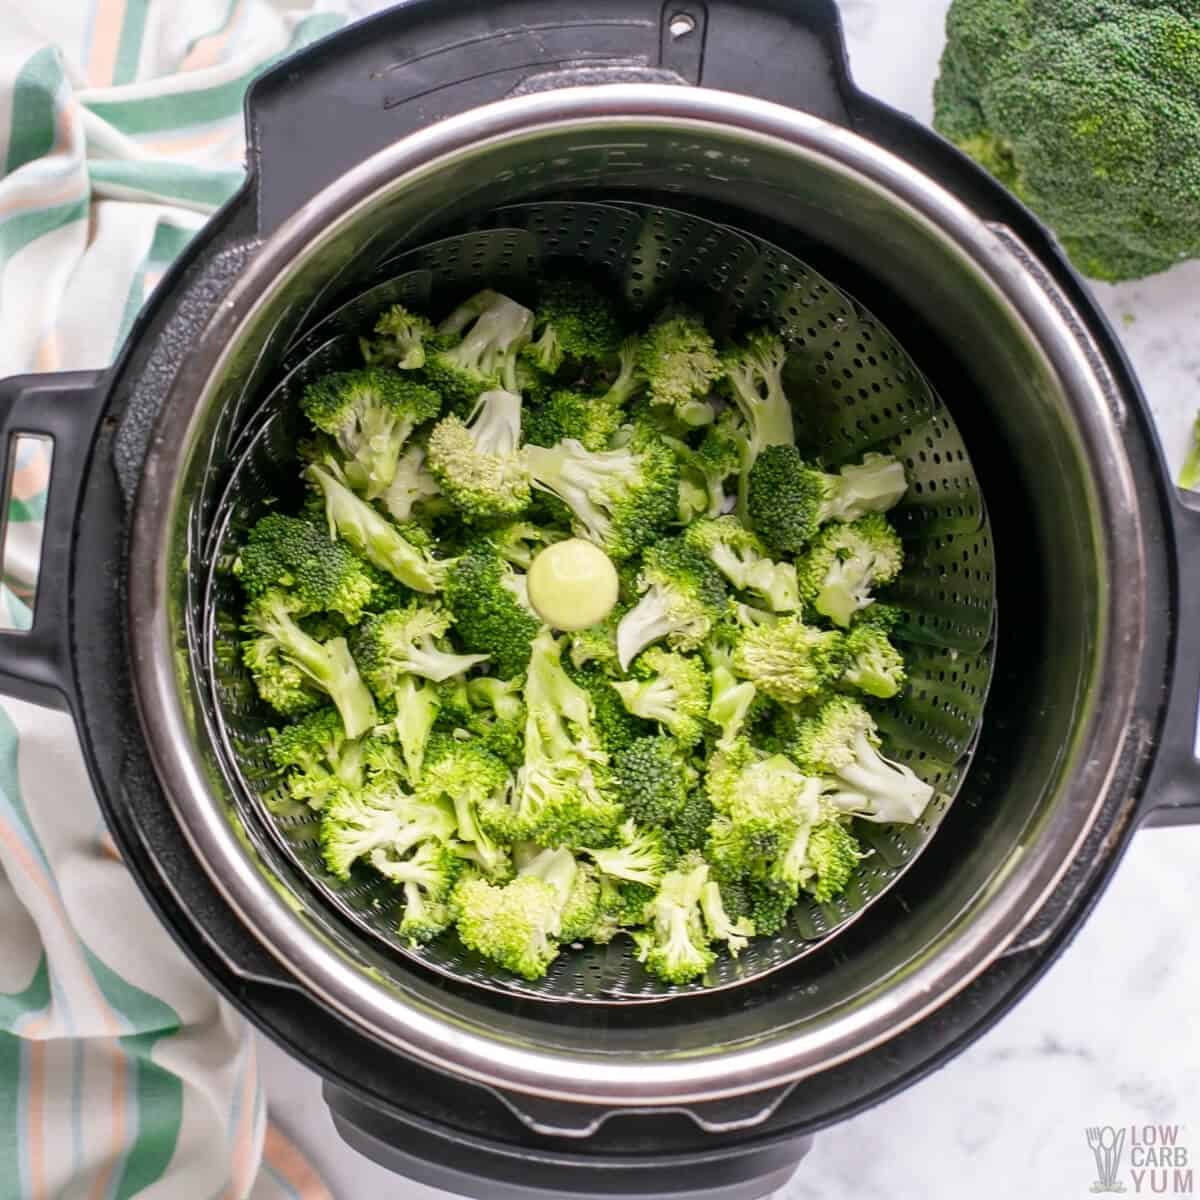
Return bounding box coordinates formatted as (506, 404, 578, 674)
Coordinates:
(262, 0, 1200, 1200)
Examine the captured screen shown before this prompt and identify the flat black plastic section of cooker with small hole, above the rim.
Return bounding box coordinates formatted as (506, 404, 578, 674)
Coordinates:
(246, 0, 854, 235)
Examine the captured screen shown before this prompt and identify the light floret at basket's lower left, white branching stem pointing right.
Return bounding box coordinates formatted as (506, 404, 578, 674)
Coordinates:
(320, 785, 455, 880)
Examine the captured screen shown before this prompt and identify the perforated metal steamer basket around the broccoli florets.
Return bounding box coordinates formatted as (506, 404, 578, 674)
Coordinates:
(204, 202, 995, 1004)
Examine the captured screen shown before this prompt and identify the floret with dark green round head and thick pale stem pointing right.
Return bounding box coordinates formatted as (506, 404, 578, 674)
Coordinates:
(746, 446, 908, 554)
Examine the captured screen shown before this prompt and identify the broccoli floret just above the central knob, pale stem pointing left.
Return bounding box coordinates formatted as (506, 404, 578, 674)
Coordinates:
(526, 433, 679, 559)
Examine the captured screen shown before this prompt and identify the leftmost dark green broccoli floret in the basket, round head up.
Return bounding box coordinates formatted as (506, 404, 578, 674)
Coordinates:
(234, 512, 374, 624)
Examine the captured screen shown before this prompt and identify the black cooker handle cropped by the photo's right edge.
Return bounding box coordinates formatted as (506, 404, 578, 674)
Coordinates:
(1145, 491, 1200, 826)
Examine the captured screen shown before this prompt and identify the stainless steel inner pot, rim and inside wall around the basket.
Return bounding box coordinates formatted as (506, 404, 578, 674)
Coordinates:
(128, 85, 1146, 1105)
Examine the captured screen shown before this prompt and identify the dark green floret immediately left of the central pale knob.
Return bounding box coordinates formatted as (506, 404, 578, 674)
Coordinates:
(444, 541, 541, 679)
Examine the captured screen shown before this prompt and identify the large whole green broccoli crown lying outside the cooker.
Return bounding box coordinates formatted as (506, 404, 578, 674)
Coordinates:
(934, 0, 1200, 281)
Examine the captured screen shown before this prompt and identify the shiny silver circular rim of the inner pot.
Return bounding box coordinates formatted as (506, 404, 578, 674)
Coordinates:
(127, 84, 1146, 1105)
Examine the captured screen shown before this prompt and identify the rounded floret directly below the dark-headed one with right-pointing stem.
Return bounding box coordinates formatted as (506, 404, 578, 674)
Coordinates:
(798, 512, 904, 629)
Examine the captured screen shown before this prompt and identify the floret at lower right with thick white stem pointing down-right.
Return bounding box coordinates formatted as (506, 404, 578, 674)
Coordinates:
(788, 696, 934, 823)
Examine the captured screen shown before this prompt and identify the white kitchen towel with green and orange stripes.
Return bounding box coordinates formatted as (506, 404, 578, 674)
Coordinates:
(0, 0, 342, 1200)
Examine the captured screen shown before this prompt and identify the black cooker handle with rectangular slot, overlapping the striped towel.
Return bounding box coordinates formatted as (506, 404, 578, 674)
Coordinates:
(0, 371, 107, 708)
